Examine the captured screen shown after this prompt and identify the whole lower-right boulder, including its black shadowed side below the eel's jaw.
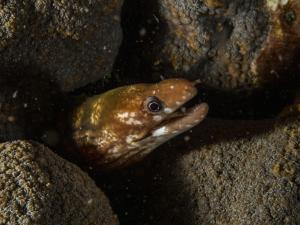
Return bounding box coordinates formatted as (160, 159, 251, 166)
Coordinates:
(102, 114, 300, 225)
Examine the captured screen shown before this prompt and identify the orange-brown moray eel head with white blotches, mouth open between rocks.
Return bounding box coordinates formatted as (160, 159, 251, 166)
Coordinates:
(71, 79, 208, 169)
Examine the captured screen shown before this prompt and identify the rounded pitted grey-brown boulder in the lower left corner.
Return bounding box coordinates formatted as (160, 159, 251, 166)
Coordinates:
(0, 141, 119, 225)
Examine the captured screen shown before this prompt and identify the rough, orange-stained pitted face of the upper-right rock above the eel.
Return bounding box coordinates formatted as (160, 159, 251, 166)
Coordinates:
(117, 0, 300, 90)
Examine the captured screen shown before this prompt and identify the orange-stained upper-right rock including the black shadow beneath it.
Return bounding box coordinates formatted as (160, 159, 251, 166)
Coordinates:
(113, 0, 300, 119)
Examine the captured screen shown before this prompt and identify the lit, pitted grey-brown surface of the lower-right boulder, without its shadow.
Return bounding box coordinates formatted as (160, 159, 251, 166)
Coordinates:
(147, 120, 300, 225)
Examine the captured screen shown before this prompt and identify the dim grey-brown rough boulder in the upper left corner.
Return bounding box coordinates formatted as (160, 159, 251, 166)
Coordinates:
(0, 0, 123, 91)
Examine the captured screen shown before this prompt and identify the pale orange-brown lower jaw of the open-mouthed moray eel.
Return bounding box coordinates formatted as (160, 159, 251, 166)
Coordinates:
(152, 103, 208, 138)
